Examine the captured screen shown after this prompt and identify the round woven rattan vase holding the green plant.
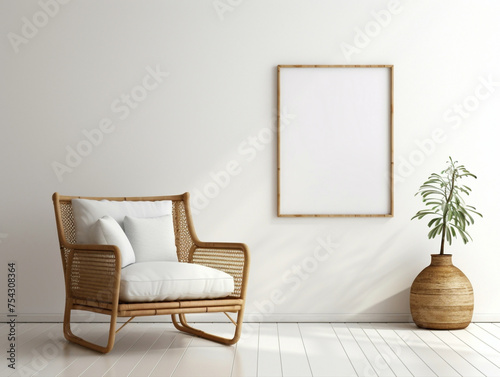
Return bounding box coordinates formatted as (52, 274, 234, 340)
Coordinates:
(410, 254, 474, 330)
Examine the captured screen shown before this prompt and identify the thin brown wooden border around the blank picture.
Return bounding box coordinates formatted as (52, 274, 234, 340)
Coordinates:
(277, 65, 394, 217)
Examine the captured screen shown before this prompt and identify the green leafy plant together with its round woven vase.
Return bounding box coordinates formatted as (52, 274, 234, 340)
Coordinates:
(410, 157, 482, 330)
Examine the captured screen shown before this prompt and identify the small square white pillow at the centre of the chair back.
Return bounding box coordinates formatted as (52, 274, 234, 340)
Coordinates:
(123, 215, 178, 262)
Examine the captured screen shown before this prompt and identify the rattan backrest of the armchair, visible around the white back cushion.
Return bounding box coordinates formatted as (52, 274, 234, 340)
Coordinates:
(52, 193, 197, 271)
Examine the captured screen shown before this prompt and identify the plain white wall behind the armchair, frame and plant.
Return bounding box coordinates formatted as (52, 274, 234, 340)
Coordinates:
(0, 0, 500, 321)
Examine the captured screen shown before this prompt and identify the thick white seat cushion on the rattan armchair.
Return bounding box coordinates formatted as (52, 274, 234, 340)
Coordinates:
(120, 262, 234, 302)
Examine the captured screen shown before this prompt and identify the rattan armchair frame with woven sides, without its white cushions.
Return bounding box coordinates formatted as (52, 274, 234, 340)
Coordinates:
(52, 193, 249, 353)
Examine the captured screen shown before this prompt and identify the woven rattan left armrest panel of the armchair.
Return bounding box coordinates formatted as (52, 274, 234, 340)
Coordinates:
(65, 244, 121, 304)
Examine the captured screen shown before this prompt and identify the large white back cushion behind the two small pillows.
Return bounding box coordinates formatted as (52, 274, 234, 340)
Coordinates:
(71, 199, 172, 243)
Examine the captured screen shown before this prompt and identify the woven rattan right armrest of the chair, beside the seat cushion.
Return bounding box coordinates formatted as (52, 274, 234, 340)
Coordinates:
(189, 241, 250, 299)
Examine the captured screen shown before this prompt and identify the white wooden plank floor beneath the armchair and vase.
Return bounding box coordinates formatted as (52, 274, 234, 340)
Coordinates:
(0, 323, 500, 377)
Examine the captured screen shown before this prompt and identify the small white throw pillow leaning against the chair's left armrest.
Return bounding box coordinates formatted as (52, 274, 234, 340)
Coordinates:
(89, 216, 135, 268)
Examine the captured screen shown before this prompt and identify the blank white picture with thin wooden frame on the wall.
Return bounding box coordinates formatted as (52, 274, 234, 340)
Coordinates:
(278, 65, 394, 217)
